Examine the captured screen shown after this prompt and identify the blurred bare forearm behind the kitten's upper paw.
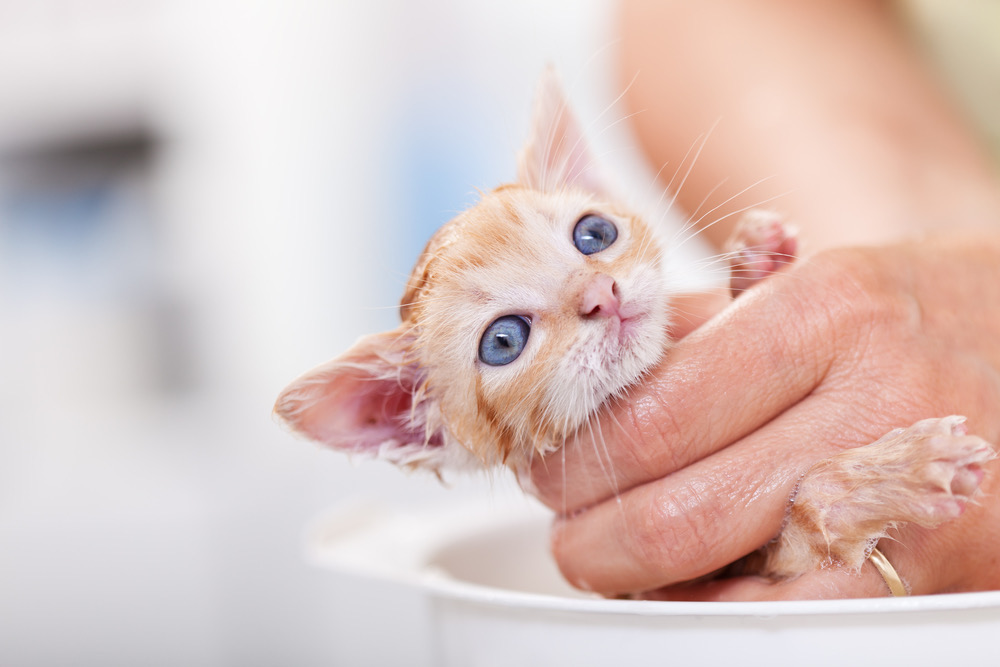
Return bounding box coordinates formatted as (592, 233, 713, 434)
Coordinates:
(621, 0, 1000, 252)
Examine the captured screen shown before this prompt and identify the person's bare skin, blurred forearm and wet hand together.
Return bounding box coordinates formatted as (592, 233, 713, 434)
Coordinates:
(531, 0, 1000, 599)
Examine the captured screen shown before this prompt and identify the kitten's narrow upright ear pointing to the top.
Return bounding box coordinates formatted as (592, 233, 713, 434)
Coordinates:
(517, 67, 605, 195)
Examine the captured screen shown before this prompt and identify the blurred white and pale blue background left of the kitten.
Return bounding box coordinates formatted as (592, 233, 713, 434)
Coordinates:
(0, 0, 672, 666)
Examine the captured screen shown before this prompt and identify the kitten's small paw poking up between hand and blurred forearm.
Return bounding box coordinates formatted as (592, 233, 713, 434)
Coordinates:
(725, 209, 798, 297)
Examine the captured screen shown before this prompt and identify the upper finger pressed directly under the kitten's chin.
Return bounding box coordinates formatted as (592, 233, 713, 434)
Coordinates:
(526, 256, 863, 512)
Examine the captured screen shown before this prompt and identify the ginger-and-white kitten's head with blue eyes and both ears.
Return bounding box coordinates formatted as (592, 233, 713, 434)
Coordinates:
(275, 73, 667, 470)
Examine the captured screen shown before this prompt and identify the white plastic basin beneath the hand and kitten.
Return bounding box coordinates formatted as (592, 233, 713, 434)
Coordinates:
(309, 502, 1000, 667)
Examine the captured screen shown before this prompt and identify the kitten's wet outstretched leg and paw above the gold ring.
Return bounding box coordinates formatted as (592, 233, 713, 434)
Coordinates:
(765, 416, 996, 576)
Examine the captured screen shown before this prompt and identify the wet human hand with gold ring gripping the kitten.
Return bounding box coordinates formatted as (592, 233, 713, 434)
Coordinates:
(530, 234, 1000, 599)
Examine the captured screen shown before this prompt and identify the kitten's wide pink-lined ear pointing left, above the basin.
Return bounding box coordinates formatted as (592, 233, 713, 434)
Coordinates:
(274, 325, 444, 470)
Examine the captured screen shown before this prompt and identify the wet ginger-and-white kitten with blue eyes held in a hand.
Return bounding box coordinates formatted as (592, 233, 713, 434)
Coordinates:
(275, 73, 994, 588)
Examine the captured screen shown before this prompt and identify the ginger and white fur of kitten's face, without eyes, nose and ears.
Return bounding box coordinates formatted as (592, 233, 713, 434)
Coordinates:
(413, 186, 667, 461)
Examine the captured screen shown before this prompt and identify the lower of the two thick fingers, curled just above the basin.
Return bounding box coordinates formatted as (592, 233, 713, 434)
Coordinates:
(552, 387, 940, 594)
